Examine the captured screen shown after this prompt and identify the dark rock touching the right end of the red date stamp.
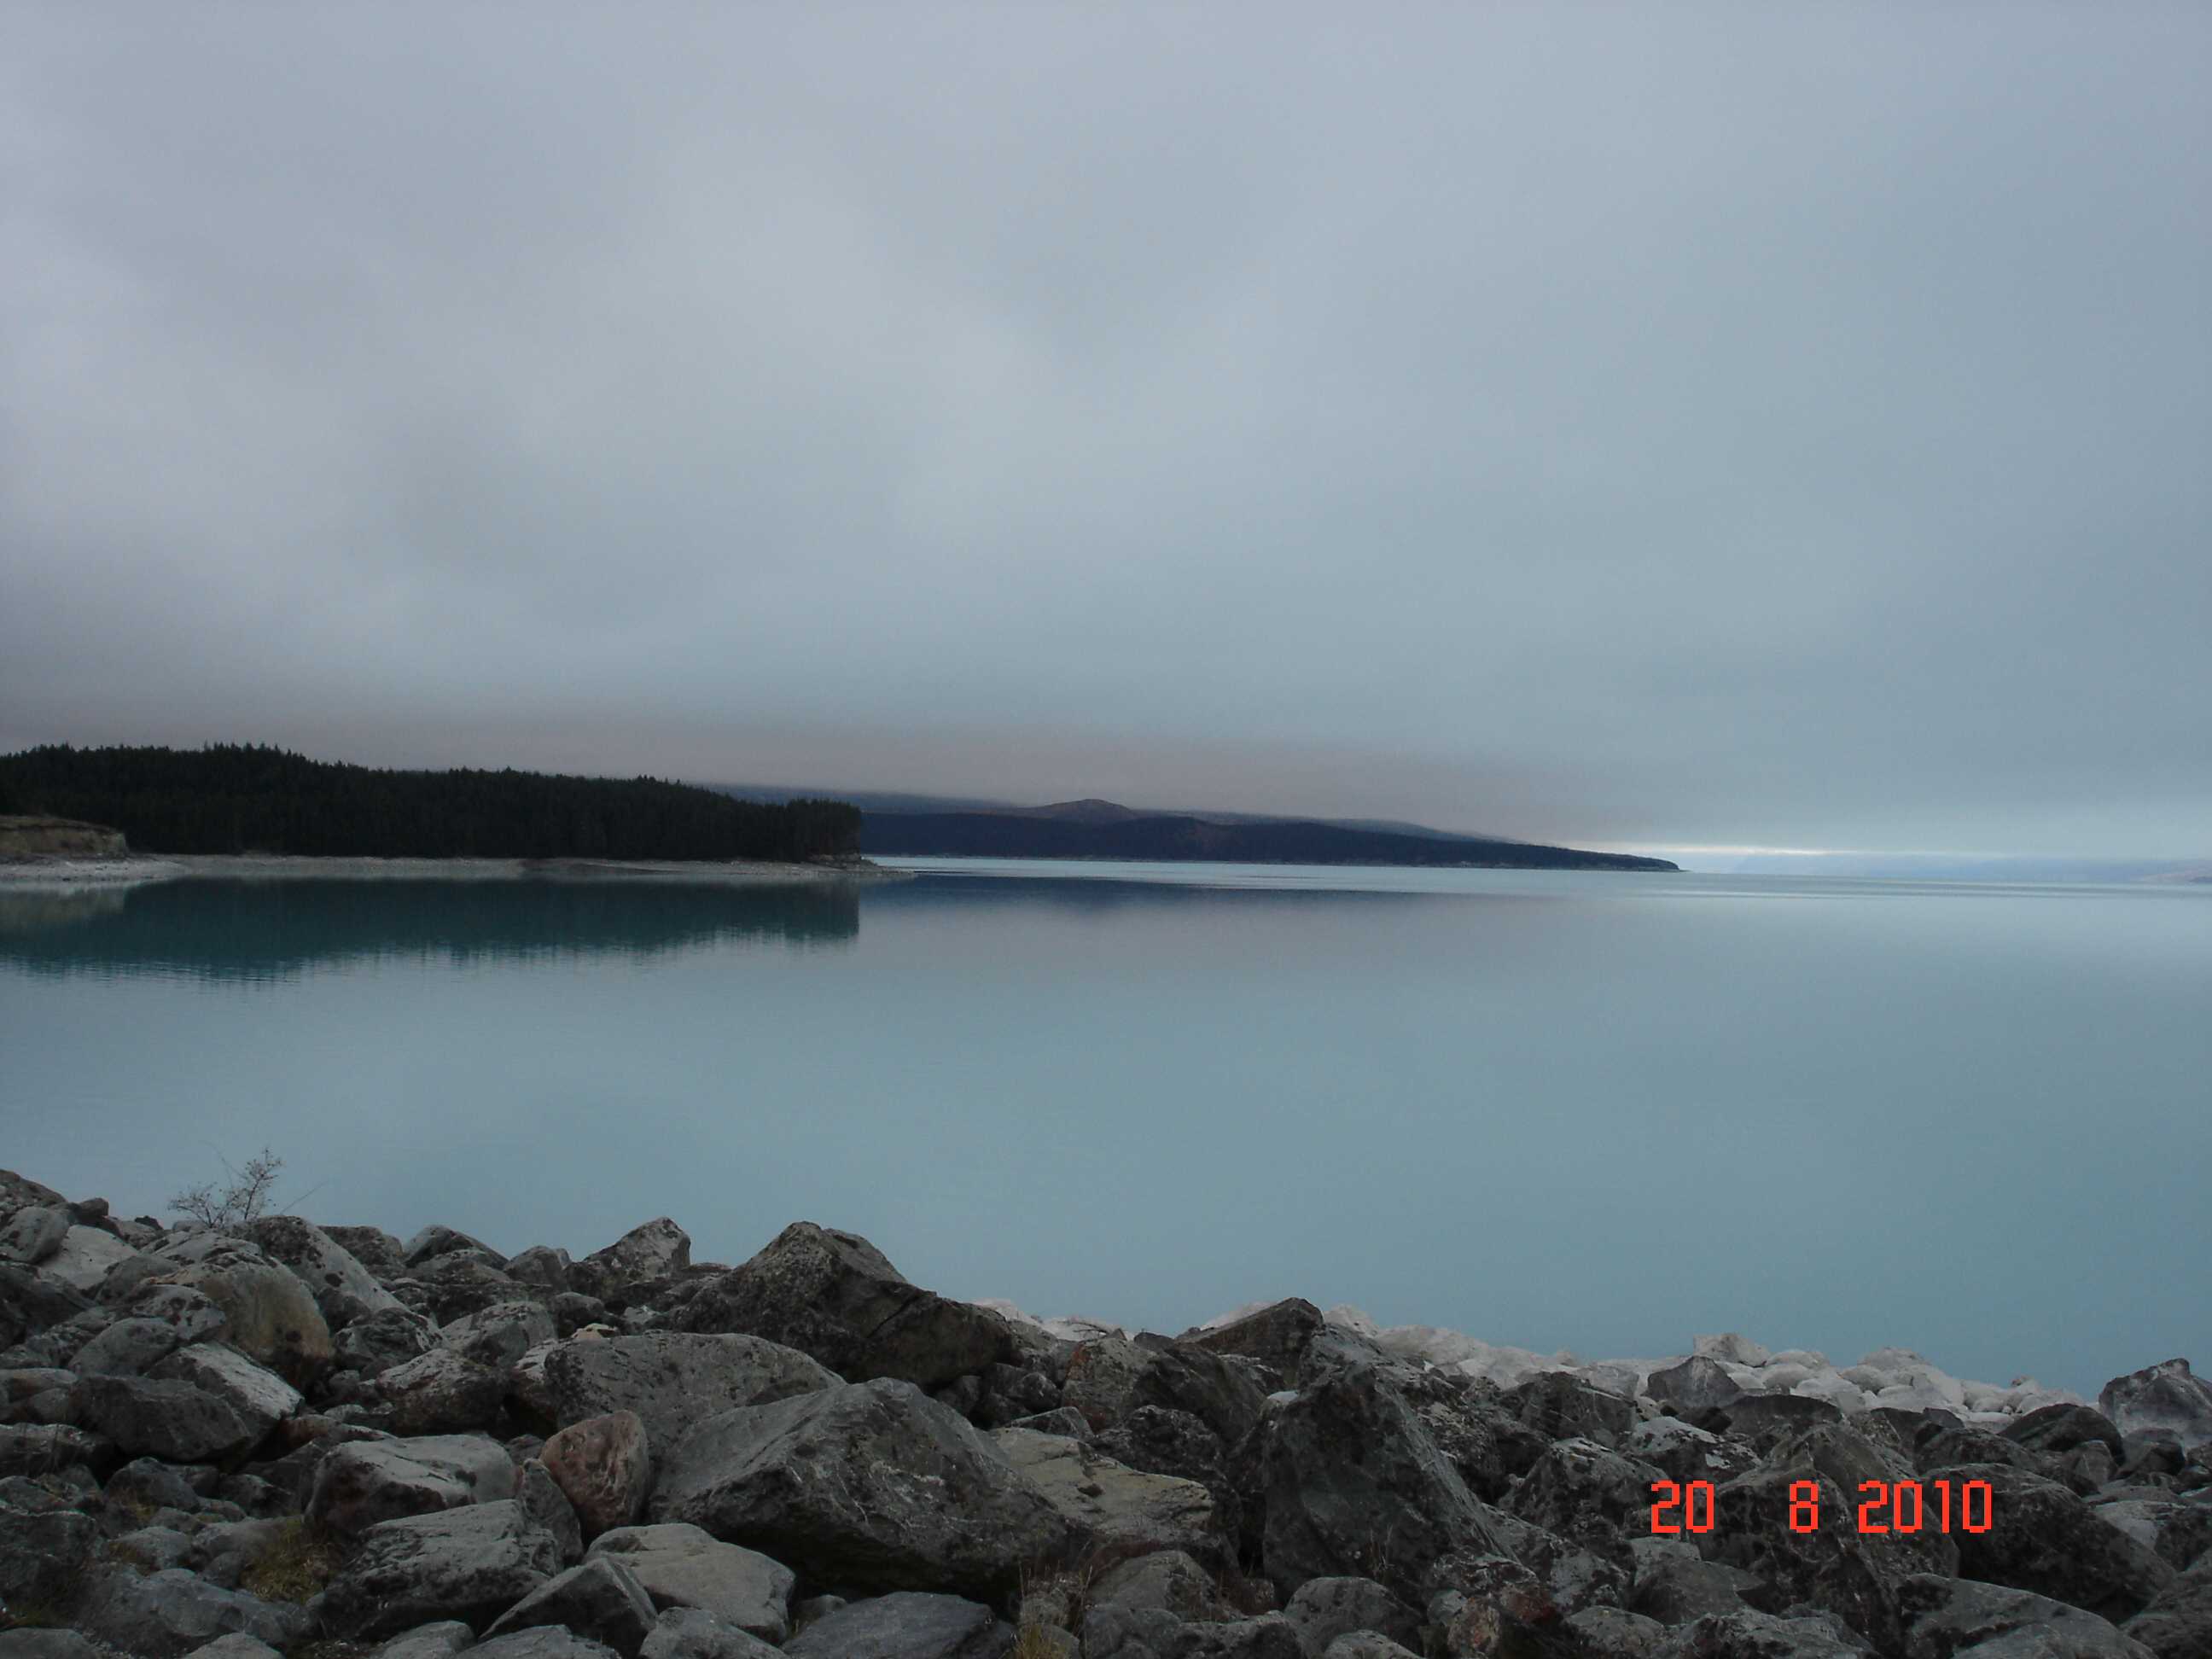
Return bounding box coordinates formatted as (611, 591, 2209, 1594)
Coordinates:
(1936, 1462, 2174, 1624)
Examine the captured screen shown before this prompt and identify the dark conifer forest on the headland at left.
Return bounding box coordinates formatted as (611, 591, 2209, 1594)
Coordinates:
(0, 743, 860, 860)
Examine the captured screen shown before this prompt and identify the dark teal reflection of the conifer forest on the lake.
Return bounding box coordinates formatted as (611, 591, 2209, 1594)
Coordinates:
(0, 881, 860, 980)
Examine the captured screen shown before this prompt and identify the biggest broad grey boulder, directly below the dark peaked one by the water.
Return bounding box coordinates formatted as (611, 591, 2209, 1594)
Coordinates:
(653, 1378, 1077, 1597)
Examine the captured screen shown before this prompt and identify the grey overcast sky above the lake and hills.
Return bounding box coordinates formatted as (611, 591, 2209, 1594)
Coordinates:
(0, 0, 2212, 856)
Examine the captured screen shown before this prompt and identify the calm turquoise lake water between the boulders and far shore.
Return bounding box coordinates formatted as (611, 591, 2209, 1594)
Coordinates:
(0, 860, 2212, 1391)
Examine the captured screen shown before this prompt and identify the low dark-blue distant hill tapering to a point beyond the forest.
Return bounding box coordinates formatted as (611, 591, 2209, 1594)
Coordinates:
(860, 800, 1677, 870)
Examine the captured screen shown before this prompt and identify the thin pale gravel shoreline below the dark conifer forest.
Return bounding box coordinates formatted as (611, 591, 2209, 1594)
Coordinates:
(0, 854, 911, 887)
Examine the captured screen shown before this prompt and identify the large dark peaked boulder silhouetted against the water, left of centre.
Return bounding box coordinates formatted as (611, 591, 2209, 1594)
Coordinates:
(681, 1221, 1017, 1389)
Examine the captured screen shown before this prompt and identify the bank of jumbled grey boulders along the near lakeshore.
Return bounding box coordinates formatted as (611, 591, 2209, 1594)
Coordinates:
(0, 1173, 2212, 1659)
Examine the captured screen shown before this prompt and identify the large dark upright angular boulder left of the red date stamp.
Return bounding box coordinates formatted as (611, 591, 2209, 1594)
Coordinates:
(1245, 1365, 1506, 1602)
